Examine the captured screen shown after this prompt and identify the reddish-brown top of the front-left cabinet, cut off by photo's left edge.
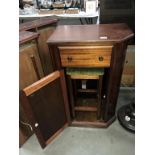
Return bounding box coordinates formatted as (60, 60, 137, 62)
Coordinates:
(19, 31, 39, 45)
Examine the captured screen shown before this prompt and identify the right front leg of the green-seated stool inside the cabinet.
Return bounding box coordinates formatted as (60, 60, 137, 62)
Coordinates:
(97, 75, 103, 119)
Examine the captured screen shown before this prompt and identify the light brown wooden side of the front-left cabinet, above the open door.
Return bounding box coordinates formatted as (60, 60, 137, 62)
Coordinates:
(19, 42, 43, 89)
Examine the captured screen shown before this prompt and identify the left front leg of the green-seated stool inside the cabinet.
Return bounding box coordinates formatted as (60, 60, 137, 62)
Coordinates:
(67, 75, 75, 118)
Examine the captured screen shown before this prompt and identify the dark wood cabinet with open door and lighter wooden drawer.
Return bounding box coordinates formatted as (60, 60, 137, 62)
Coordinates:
(20, 24, 134, 147)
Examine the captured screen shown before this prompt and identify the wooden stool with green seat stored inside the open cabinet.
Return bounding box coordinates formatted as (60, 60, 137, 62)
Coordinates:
(66, 68, 104, 122)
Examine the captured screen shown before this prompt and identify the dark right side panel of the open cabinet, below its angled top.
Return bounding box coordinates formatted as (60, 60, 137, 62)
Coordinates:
(103, 42, 127, 121)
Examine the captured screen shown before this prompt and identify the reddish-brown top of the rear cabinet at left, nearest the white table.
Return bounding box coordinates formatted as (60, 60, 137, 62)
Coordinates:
(19, 18, 58, 31)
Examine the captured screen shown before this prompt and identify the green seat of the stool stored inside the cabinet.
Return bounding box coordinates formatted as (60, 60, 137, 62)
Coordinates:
(66, 67, 104, 79)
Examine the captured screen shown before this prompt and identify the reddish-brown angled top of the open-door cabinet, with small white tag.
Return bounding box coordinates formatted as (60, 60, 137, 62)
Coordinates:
(47, 23, 134, 44)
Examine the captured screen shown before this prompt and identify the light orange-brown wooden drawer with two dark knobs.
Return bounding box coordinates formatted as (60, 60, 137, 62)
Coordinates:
(59, 46, 112, 67)
